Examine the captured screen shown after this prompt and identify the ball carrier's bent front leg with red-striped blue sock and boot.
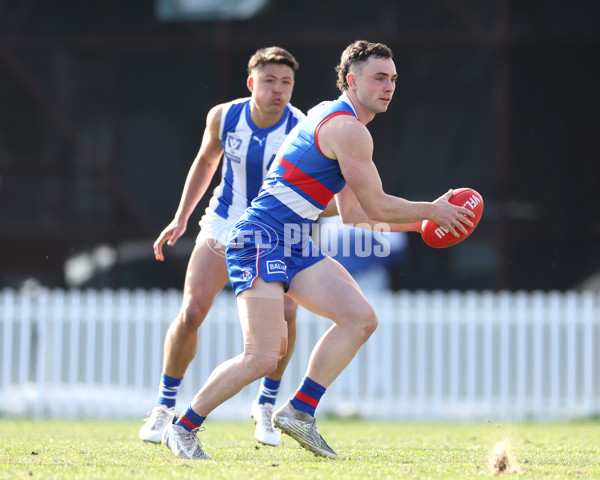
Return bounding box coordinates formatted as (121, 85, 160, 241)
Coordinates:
(273, 257, 377, 458)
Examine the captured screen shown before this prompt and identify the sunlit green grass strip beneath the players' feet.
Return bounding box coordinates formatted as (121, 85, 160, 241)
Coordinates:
(0, 418, 600, 480)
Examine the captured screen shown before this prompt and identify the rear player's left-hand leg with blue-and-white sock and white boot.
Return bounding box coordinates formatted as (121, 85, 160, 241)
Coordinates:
(139, 238, 228, 443)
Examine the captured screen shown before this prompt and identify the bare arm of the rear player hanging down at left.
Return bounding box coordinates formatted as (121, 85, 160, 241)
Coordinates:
(154, 105, 223, 261)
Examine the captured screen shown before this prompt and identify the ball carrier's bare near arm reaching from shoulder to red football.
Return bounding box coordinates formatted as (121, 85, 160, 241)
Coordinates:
(319, 115, 474, 237)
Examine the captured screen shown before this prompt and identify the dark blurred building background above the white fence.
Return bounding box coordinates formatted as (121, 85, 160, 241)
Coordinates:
(0, 0, 600, 290)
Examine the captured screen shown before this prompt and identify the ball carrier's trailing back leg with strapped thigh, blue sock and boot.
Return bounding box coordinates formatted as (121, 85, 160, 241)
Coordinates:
(165, 277, 287, 458)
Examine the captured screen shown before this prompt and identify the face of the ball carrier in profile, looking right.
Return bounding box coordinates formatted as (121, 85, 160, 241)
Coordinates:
(356, 57, 398, 113)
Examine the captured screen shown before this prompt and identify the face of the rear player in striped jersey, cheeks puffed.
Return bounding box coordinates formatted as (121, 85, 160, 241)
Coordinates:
(248, 63, 294, 114)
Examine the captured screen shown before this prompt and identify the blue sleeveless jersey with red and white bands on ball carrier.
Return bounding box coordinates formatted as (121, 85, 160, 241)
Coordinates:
(242, 95, 357, 233)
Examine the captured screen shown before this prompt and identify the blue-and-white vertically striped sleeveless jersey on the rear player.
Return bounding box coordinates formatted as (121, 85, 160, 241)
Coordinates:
(207, 97, 305, 225)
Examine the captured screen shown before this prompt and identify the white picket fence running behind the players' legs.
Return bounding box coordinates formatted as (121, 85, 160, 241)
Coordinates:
(0, 289, 600, 421)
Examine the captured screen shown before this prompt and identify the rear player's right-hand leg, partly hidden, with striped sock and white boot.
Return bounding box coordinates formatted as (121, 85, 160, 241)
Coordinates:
(250, 295, 298, 446)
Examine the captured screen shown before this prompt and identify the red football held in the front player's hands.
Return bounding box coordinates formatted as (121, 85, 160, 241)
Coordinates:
(421, 188, 483, 248)
